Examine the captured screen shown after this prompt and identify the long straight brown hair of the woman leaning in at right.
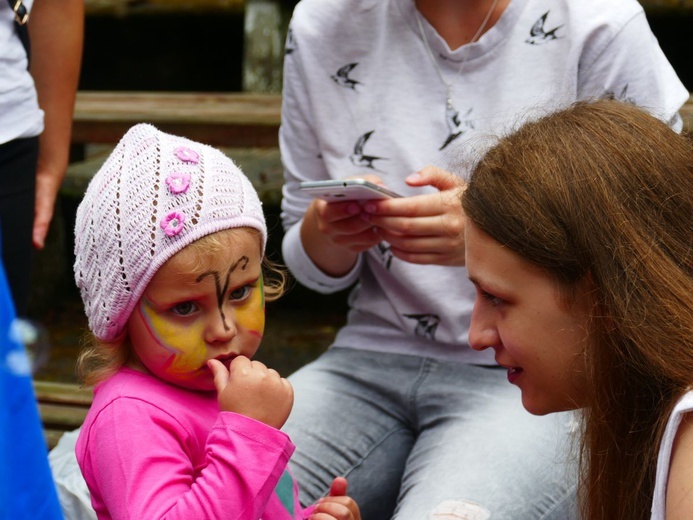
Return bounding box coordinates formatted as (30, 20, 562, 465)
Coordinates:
(463, 101, 693, 520)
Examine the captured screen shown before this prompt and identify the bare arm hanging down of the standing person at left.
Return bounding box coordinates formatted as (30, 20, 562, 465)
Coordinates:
(29, 0, 84, 249)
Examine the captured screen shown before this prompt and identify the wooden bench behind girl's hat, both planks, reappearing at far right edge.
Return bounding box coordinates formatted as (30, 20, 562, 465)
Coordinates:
(61, 92, 693, 204)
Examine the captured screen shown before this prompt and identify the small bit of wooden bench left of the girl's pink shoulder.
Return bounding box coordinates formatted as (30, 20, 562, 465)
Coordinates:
(34, 381, 93, 448)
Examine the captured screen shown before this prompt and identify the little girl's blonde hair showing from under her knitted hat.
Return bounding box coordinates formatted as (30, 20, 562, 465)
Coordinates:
(77, 228, 287, 386)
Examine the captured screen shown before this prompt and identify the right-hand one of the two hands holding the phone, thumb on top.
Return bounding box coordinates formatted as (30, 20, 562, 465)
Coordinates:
(362, 166, 466, 265)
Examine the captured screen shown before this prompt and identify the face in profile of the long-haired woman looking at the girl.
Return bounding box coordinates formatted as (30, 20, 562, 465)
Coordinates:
(465, 219, 589, 415)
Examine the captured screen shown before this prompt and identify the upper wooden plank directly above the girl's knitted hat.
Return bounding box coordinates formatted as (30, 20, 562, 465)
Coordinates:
(72, 91, 281, 147)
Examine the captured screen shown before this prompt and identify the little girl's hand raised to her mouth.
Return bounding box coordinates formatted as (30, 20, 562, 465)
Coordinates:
(207, 356, 294, 429)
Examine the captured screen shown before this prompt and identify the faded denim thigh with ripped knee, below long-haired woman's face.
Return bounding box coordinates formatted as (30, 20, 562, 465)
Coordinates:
(394, 360, 577, 520)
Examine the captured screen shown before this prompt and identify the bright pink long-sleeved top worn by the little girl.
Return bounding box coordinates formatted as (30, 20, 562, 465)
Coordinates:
(76, 368, 309, 520)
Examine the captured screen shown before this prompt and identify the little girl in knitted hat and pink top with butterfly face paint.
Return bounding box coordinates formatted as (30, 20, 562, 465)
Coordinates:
(74, 124, 360, 520)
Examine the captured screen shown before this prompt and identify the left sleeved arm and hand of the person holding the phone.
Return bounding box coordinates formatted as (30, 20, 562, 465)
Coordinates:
(279, 22, 378, 293)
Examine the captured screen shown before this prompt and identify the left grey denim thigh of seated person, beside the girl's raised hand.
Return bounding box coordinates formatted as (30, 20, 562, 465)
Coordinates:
(283, 348, 420, 520)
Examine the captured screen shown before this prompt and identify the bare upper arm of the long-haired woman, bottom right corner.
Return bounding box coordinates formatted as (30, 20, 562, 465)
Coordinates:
(666, 413, 693, 520)
